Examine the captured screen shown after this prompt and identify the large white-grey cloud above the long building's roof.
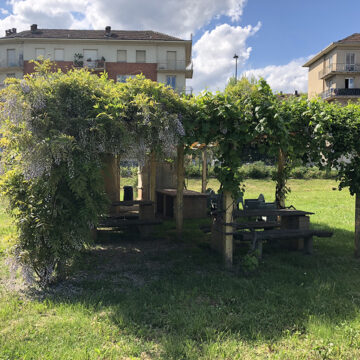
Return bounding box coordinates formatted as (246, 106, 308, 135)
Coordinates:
(0, 0, 247, 38)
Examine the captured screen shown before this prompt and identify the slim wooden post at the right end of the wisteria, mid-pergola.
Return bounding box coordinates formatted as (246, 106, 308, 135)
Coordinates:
(175, 143, 184, 238)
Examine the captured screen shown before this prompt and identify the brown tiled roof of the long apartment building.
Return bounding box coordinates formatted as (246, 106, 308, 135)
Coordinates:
(0, 29, 188, 41)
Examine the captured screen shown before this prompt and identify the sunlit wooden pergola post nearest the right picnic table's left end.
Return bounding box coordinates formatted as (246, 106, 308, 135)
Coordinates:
(222, 191, 234, 268)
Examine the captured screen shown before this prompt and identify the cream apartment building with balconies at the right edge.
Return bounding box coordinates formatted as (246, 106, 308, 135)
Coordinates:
(303, 34, 360, 103)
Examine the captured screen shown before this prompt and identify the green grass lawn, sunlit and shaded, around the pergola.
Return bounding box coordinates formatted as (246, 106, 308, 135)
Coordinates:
(0, 180, 360, 359)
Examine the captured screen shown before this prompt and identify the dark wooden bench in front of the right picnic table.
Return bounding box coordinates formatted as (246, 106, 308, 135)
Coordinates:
(233, 229, 333, 258)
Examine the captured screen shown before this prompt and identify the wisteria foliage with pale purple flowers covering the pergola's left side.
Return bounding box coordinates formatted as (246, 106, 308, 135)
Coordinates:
(0, 61, 184, 285)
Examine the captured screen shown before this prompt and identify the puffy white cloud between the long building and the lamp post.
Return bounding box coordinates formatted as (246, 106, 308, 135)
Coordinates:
(189, 23, 261, 92)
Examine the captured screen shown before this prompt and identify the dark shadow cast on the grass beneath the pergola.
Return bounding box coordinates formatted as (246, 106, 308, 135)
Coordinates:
(40, 222, 360, 358)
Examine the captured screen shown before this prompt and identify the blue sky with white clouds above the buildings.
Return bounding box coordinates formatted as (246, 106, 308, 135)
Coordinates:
(0, 0, 360, 92)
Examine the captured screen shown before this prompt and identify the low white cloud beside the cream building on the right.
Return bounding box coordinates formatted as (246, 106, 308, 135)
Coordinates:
(242, 57, 310, 93)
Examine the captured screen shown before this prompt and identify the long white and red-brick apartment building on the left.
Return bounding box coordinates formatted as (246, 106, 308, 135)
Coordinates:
(0, 24, 193, 93)
